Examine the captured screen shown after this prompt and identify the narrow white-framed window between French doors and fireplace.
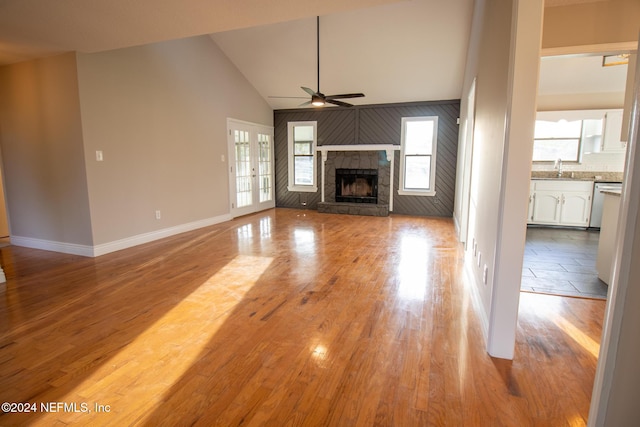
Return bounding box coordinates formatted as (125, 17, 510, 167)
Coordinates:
(288, 122, 318, 192)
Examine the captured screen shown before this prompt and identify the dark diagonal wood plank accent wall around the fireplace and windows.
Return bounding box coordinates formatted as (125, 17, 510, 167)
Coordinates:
(273, 100, 460, 217)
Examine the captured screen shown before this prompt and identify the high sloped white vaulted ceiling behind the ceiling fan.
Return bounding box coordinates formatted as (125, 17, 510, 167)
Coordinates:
(212, 0, 473, 109)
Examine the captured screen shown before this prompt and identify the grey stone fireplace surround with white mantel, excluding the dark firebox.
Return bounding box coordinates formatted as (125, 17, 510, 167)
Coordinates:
(318, 145, 400, 216)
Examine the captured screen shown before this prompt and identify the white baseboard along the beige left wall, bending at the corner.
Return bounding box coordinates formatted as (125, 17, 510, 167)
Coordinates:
(11, 214, 232, 257)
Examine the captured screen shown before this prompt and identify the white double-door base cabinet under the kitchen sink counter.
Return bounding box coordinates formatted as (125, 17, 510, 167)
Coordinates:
(527, 179, 593, 227)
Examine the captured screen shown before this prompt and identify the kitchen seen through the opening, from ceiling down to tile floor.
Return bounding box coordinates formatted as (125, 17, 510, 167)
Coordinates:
(521, 51, 628, 299)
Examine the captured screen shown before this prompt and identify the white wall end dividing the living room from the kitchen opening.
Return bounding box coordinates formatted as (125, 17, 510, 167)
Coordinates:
(461, 0, 542, 358)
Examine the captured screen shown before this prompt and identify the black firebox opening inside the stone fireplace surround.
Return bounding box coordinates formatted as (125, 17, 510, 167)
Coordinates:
(336, 169, 378, 204)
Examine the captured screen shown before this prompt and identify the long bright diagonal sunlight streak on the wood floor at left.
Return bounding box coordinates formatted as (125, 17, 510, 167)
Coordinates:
(53, 255, 273, 423)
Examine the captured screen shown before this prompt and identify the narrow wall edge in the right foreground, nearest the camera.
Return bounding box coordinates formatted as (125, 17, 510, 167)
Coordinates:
(589, 51, 640, 426)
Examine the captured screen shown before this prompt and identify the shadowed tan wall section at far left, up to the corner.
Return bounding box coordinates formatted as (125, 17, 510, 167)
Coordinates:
(0, 53, 92, 246)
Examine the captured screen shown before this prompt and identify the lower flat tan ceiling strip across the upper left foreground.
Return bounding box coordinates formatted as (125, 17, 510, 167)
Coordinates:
(0, 0, 408, 64)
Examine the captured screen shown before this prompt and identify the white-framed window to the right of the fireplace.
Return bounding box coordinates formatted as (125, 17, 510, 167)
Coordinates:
(398, 116, 438, 196)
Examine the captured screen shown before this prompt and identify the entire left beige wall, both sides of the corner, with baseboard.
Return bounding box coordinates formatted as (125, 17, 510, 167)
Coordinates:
(0, 36, 273, 255)
